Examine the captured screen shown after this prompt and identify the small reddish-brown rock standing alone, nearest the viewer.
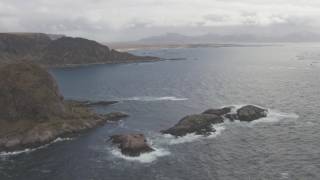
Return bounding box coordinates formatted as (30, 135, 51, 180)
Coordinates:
(111, 134, 154, 156)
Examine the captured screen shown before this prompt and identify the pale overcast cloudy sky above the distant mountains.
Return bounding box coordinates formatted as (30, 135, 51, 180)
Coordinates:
(0, 0, 320, 41)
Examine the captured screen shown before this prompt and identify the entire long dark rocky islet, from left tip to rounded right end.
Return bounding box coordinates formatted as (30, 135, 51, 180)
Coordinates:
(161, 105, 268, 137)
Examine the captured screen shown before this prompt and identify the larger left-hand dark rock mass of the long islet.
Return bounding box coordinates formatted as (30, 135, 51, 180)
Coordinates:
(161, 114, 223, 136)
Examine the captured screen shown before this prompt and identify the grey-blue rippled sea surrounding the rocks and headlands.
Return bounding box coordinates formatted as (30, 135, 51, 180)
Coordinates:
(0, 44, 320, 180)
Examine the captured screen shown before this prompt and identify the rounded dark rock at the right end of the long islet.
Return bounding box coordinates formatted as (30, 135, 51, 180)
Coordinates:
(237, 105, 268, 121)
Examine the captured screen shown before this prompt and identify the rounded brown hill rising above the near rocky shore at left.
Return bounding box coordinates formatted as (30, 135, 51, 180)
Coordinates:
(0, 63, 65, 121)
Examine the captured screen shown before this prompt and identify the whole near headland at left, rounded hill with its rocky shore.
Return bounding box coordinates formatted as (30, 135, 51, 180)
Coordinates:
(0, 63, 127, 151)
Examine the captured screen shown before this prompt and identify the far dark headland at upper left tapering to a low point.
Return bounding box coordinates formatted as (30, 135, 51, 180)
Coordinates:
(0, 33, 158, 66)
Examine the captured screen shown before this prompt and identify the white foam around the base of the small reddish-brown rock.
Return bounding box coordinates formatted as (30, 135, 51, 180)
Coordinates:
(111, 147, 170, 163)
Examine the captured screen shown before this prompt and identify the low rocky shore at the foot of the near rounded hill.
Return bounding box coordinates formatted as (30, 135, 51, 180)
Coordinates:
(0, 107, 128, 152)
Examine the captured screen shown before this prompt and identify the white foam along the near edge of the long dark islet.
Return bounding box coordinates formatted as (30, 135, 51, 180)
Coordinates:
(162, 124, 225, 145)
